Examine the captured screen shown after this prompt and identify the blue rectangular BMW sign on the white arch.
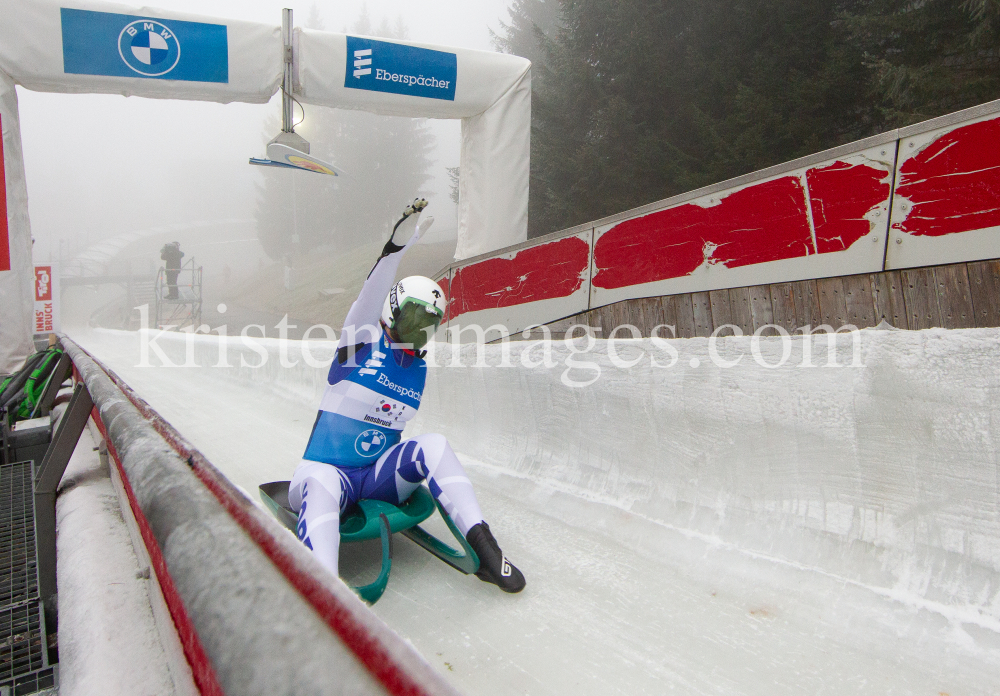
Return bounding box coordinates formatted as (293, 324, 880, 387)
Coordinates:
(61, 7, 229, 82)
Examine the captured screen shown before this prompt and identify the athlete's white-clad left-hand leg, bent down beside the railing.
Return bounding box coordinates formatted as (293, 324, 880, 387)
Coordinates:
(288, 461, 351, 575)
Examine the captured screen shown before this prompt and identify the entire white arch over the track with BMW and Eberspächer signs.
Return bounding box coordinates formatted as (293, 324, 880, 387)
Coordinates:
(0, 0, 531, 372)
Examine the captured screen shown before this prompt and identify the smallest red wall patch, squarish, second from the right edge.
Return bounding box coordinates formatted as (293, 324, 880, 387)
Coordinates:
(806, 162, 892, 254)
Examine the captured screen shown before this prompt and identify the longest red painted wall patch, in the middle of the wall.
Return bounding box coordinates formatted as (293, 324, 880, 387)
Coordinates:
(593, 176, 815, 289)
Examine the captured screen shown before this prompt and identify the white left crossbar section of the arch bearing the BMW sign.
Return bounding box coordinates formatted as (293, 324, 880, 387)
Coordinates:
(0, 0, 278, 104)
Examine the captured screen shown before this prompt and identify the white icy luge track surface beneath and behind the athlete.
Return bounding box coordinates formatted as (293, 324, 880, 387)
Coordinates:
(74, 330, 1000, 696)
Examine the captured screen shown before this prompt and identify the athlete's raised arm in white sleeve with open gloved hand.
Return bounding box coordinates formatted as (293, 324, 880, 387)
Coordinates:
(337, 198, 434, 350)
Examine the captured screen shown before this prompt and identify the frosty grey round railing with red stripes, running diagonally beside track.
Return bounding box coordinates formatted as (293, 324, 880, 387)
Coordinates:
(61, 337, 456, 696)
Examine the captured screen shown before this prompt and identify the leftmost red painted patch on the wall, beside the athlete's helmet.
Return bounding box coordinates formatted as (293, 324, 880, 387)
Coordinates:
(448, 237, 590, 318)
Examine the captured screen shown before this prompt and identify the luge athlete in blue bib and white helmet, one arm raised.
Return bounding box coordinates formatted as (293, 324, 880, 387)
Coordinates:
(288, 198, 524, 592)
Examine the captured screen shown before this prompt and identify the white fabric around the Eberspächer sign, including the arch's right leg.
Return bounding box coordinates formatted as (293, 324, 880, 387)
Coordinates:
(294, 29, 531, 259)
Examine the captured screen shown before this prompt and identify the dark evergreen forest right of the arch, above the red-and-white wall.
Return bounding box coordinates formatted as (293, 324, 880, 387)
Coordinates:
(494, 0, 1000, 237)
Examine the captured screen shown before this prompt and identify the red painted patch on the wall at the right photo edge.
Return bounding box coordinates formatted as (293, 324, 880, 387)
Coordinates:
(892, 119, 1000, 237)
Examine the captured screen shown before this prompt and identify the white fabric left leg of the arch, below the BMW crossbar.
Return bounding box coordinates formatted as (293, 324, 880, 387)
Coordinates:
(0, 72, 35, 373)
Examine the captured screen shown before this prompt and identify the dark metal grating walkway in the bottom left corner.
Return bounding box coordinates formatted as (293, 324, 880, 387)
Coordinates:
(0, 461, 55, 696)
